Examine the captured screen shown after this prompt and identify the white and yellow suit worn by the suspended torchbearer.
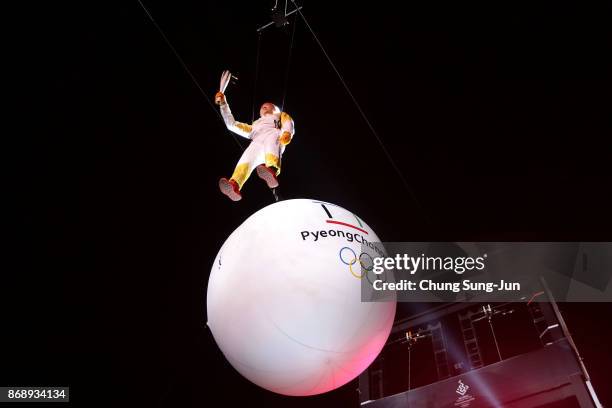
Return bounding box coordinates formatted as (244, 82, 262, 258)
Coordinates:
(220, 102, 295, 188)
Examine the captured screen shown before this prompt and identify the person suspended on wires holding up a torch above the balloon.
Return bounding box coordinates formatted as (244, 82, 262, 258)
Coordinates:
(215, 71, 295, 201)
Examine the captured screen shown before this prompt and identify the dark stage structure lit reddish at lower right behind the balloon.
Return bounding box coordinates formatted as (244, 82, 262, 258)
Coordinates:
(358, 281, 601, 408)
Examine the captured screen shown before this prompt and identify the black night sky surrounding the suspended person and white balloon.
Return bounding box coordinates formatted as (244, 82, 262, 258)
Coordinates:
(5, 0, 612, 407)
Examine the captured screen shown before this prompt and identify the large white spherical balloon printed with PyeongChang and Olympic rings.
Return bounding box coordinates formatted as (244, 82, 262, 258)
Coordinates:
(207, 199, 395, 395)
